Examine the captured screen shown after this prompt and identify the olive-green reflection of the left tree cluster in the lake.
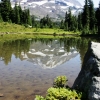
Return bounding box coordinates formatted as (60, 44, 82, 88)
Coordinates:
(0, 40, 30, 65)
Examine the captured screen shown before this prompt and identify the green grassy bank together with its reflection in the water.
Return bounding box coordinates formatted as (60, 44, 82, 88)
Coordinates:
(0, 22, 79, 43)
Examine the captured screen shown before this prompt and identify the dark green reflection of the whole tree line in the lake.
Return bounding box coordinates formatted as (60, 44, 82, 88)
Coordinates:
(0, 37, 97, 65)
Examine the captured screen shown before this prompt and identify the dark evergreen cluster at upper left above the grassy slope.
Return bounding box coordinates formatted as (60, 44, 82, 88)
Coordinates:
(0, 0, 31, 25)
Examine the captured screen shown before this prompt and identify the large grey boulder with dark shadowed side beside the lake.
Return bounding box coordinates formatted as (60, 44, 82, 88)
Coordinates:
(73, 42, 100, 100)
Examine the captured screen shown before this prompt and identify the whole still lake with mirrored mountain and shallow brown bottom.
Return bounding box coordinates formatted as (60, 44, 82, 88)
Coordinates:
(0, 37, 98, 100)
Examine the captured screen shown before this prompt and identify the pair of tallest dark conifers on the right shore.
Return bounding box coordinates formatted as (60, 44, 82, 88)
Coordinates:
(78, 0, 97, 35)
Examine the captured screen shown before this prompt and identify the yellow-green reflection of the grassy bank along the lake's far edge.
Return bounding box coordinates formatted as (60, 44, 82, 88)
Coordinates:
(0, 34, 79, 43)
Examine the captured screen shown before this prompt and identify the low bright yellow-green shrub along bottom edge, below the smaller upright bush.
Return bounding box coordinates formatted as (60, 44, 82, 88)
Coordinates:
(36, 87, 82, 100)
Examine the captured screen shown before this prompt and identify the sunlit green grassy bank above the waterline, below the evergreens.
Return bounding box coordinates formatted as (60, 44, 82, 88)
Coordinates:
(0, 22, 80, 34)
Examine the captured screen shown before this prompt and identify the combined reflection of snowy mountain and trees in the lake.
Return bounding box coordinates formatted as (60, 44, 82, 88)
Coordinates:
(0, 38, 99, 68)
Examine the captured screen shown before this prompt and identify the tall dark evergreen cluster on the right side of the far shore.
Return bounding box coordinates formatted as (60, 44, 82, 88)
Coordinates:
(60, 0, 100, 35)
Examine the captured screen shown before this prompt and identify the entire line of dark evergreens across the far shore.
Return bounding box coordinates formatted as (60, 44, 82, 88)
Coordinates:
(0, 0, 100, 35)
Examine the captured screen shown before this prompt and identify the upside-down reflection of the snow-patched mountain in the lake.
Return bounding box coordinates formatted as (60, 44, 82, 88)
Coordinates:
(20, 40, 78, 68)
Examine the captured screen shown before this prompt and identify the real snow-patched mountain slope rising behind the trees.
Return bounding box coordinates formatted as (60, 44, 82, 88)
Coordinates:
(11, 0, 82, 19)
